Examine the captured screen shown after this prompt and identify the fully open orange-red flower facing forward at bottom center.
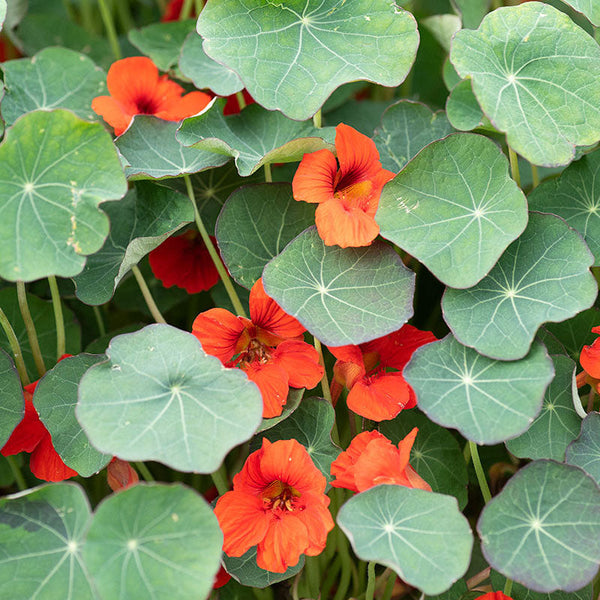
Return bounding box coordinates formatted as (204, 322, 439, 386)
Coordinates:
(215, 438, 333, 573)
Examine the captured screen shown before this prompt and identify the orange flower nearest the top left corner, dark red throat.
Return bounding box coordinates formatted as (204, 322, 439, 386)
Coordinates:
(92, 56, 212, 135)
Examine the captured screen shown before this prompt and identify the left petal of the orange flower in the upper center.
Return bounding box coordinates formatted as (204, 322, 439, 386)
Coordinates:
(292, 150, 337, 203)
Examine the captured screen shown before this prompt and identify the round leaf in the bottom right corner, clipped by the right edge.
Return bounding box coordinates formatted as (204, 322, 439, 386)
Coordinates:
(477, 460, 600, 592)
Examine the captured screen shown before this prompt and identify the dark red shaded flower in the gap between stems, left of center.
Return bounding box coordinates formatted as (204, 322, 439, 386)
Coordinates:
(148, 229, 219, 294)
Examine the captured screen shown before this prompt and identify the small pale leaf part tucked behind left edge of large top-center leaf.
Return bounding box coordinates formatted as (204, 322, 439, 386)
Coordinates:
(179, 31, 244, 96)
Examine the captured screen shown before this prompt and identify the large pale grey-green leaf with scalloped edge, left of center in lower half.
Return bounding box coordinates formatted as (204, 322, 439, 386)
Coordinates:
(77, 324, 262, 473)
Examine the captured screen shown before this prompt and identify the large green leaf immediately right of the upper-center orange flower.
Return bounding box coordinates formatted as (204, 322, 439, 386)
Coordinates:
(375, 133, 528, 288)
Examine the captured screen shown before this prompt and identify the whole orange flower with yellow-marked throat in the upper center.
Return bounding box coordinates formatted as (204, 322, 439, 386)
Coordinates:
(292, 123, 394, 248)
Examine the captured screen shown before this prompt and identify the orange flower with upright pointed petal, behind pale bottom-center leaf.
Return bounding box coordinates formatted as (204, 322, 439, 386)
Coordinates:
(331, 427, 431, 492)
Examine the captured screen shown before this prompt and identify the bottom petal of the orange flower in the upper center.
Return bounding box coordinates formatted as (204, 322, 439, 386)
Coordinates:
(315, 198, 379, 248)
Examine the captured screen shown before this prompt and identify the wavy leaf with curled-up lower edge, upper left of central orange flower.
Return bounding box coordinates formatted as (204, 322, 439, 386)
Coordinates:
(177, 100, 335, 177)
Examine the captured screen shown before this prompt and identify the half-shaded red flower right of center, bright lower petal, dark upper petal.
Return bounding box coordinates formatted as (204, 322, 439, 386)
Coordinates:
(329, 325, 436, 421)
